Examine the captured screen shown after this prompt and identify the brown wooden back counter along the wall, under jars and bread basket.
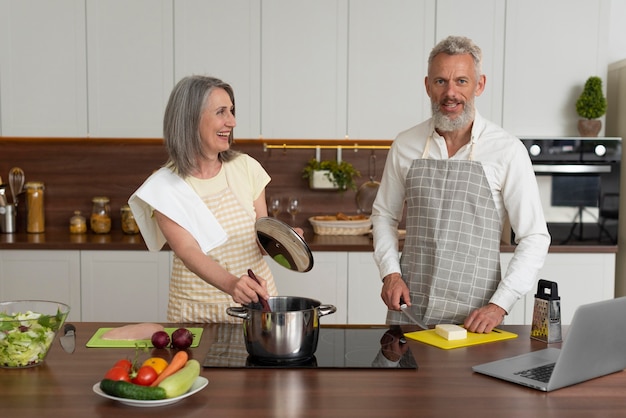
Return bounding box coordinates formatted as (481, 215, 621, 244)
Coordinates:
(0, 227, 617, 253)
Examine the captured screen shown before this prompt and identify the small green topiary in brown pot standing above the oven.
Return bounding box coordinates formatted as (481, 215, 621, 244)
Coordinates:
(576, 77, 606, 136)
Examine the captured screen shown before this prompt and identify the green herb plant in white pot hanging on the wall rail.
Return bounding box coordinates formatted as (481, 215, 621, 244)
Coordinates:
(302, 158, 361, 191)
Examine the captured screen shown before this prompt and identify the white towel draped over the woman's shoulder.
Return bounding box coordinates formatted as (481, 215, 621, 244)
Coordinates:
(128, 167, 228, 253)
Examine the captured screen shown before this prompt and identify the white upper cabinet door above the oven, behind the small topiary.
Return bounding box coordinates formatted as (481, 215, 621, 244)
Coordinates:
(500, 0, 610, 136)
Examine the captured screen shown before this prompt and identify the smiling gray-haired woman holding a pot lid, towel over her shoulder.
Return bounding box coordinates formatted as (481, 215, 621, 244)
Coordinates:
(129, 76, 277, 322)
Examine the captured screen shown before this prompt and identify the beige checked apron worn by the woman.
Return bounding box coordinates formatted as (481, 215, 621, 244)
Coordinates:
(167, 187, 277, 323)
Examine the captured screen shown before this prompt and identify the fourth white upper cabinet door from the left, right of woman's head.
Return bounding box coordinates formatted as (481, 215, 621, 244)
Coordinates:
(261, 0, 346, 138)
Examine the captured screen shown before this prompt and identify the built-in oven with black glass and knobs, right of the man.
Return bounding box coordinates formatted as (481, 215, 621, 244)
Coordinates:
(521, 137, 622, 245)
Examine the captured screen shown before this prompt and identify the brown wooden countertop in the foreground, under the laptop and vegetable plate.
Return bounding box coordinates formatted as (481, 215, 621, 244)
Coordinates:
(0, 323, 626, 418)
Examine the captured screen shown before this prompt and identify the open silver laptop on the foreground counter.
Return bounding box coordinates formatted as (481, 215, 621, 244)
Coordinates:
(472, 297, 626, 392)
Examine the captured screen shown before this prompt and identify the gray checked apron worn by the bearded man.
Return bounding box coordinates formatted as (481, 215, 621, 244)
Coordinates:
(387, 136, 502, 324)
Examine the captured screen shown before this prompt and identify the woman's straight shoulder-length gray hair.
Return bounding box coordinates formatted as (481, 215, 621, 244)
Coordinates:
(163, 75, 239, 177)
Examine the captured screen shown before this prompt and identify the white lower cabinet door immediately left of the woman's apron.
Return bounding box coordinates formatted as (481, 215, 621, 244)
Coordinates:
(80, 251, 171, 322)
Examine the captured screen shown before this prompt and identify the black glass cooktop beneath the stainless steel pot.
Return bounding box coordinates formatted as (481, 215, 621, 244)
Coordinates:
(203, 324, 417, 369)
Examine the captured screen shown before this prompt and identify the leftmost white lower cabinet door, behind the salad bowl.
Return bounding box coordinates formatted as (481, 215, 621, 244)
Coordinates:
(0, 250, 84, 321)
